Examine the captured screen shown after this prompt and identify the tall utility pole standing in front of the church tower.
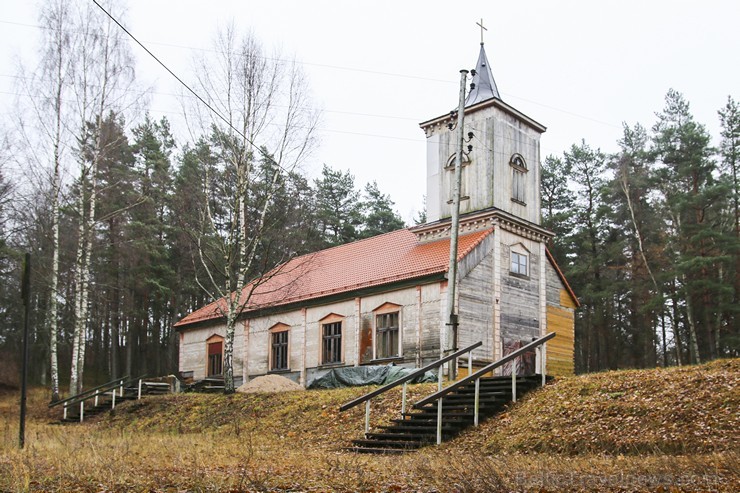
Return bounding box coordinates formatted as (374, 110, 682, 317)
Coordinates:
(445, 69, 468, 380)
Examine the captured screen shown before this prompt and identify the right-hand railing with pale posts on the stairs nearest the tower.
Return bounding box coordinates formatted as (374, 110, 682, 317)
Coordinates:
(413, 332, 555, 445)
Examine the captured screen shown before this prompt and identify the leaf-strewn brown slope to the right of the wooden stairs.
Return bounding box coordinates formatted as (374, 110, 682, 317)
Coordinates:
(460, 359, 740, 454)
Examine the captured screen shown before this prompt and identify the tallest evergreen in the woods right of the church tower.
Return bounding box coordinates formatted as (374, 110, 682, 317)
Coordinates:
(652, 89, 732, 362)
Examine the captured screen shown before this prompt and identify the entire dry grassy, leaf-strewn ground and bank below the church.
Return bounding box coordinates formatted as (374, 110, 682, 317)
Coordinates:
(0, 360, 740, 492)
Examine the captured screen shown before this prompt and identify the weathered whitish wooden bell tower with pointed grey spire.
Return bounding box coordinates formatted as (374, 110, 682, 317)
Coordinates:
(420, 42, 546, 225)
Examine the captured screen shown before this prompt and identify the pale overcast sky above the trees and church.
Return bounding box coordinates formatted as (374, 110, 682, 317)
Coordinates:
(0, 0, 740, 221)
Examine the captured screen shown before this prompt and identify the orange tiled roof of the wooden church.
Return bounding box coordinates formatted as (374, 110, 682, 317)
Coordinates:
(175, 229, 493, 327)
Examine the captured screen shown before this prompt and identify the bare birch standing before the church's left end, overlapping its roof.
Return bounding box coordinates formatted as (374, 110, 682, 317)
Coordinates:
(186, 25, 317, 393)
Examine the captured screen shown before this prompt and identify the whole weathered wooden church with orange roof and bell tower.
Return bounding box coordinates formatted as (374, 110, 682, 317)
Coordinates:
(175, 43, 578, 386)
